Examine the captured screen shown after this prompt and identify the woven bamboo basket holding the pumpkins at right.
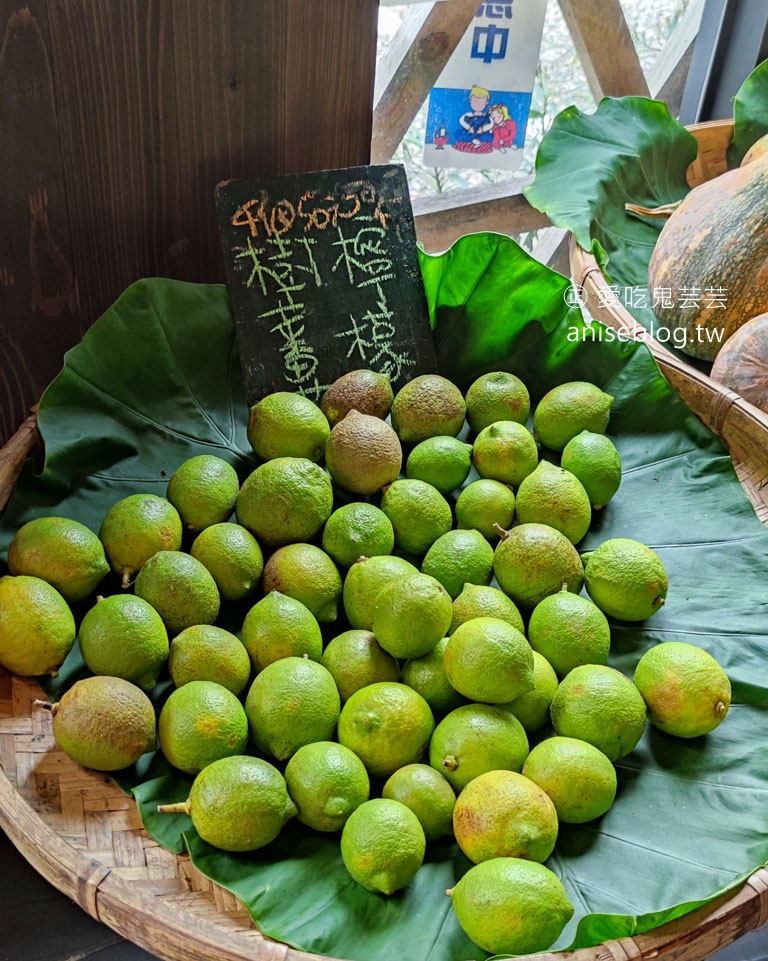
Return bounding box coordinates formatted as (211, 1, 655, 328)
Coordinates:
(570, 120, 768, 524)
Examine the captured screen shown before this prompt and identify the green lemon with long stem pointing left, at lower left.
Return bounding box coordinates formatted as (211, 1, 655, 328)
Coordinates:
(158, 755, 296, 851)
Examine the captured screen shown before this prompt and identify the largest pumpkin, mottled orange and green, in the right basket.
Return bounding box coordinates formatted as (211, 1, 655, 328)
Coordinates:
(648, 153, 768, 360)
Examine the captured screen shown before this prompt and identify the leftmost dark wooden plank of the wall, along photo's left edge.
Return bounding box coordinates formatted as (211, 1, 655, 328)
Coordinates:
(0, 0, 82, 445)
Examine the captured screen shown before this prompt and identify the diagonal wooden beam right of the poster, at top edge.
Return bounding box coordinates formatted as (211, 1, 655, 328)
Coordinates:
(558, 0, 650, 102)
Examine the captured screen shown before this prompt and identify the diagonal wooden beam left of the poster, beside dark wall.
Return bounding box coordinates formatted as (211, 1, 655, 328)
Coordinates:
(371, 0, 479, 163)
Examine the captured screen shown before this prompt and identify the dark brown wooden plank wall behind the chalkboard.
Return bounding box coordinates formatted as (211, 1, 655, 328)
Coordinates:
(0, 0, 378, 443)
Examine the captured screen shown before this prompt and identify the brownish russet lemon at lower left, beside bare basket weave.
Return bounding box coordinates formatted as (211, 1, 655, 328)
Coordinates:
(50, 676, 157, 771)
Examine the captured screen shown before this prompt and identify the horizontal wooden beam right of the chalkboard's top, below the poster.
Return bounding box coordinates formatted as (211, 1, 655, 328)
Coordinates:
(413, 177, 551, 253)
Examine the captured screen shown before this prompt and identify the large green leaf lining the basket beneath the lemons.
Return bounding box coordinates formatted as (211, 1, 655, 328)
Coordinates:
(0, 234, 768, 961)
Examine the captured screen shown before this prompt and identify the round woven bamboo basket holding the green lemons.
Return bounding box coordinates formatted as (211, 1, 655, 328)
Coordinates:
(0, 298, 768, 961)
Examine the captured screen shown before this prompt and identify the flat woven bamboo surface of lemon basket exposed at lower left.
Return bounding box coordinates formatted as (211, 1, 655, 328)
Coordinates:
(0, 668, 292, 961)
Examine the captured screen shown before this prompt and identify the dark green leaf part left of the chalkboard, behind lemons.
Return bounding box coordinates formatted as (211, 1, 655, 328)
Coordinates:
(0, 279, 255, 556)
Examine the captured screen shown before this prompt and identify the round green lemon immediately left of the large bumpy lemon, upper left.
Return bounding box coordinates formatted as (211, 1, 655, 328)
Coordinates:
(165, 454, 240, 531)
